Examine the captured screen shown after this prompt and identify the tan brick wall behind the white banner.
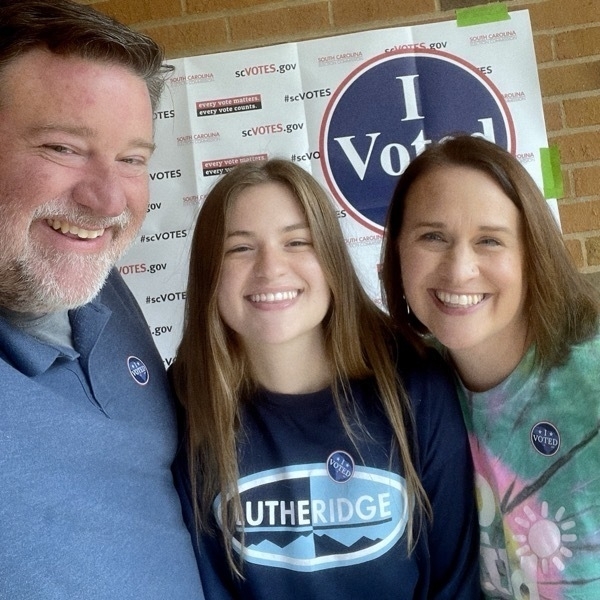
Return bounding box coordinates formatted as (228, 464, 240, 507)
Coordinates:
(80, 0, 600, 287)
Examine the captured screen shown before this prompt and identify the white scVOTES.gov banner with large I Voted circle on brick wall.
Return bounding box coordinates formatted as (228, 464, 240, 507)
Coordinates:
(119, 11, 557, 365)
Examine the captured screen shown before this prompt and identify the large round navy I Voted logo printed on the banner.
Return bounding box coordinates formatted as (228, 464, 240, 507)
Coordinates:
(319, 49, 515, 233)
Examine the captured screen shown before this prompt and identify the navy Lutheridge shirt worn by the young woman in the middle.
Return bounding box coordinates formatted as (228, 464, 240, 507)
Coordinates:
(176, 350, 480, 600)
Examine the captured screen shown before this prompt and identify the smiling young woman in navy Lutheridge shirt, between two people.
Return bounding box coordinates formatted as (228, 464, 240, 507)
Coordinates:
(171, 160, 478, 600)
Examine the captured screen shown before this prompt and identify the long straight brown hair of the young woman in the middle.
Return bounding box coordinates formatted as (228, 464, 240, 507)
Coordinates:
(171, 159, 431, 575)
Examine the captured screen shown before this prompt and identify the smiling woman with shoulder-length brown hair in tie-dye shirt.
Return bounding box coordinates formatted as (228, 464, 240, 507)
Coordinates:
(382, 136, 600, 599)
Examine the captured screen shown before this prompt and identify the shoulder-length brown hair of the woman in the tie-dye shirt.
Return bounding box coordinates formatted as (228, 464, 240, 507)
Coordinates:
(381, 135, 599, 368)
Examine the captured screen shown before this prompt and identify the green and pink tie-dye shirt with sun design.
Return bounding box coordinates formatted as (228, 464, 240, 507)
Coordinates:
(459, 336, 600, 600)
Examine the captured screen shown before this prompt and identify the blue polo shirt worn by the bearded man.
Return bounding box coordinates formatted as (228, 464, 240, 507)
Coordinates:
(0, 271, 203, 600)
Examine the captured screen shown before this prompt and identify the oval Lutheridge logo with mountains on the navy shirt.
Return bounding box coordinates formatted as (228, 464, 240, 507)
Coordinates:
(213, 464, 408, 572)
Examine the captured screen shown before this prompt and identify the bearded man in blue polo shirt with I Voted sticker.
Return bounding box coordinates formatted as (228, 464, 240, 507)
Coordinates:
(0, 0, 203, 600)
